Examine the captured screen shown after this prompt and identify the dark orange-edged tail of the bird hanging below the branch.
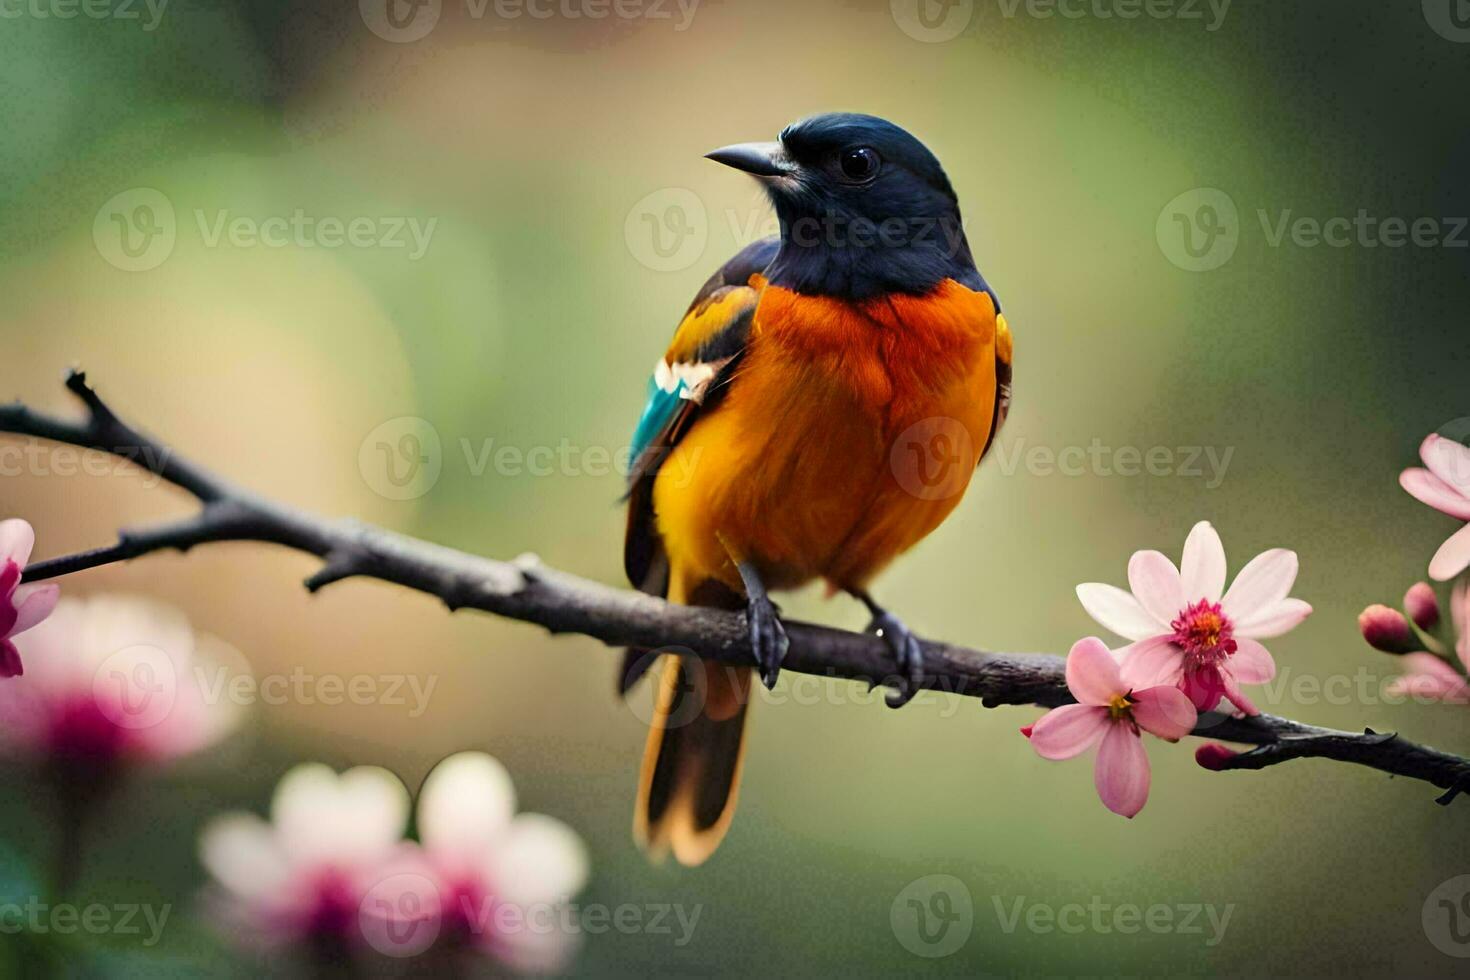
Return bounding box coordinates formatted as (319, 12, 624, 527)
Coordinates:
(634, 576, 751, 865)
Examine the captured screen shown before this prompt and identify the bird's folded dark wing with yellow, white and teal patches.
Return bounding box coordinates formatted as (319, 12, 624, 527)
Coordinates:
(623, 238, 781, 595)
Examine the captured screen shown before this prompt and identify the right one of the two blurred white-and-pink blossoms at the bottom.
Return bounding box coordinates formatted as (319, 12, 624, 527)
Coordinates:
(417, 752, 588, 973)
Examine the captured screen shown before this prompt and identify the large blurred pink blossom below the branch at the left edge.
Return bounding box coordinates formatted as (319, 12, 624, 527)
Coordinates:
(0, 595, 243, 765)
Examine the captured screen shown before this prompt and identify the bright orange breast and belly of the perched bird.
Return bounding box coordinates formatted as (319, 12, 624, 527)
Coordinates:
(654, 282, 997, 591)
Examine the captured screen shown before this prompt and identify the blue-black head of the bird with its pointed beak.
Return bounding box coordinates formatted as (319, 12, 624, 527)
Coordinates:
(707, 113, 983, 300)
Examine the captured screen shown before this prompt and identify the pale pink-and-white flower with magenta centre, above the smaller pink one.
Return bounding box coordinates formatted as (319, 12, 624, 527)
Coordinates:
(1078, 522, 1311, 714)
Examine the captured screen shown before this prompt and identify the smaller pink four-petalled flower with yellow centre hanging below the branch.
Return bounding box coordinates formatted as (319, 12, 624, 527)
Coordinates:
(1029, 636, 1197, 817)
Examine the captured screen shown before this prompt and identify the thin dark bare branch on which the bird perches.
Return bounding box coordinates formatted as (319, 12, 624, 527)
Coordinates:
(0, 372, 1470, 804)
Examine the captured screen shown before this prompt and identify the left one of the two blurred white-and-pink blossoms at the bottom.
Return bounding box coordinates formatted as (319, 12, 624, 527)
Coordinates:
(198, 763, 409, 946)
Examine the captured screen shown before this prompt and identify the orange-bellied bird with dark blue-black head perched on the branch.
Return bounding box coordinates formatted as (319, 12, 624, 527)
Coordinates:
(619, 112, 1013, 865)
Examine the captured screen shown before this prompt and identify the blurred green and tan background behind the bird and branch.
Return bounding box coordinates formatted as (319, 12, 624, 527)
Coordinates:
(0, 0, 1470, 976)
